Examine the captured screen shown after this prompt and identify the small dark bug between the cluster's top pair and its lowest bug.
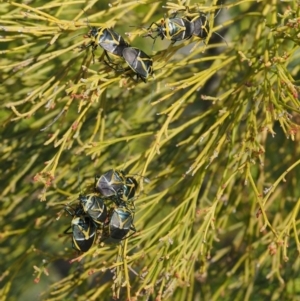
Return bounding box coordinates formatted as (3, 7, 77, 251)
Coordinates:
(79, 194, 107, 225)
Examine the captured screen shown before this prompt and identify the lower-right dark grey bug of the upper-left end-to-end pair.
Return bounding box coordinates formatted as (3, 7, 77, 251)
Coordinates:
(122, 47, 153, 82)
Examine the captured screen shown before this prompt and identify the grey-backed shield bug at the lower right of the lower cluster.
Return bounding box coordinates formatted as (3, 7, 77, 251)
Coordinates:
(109, 207, 136, 240)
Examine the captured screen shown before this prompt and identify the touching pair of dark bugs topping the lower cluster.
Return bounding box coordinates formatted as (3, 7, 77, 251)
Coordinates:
(95, 169, 138, 206)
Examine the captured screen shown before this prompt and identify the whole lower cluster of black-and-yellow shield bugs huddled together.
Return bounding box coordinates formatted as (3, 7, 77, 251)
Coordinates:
(65, 169, 138, 252)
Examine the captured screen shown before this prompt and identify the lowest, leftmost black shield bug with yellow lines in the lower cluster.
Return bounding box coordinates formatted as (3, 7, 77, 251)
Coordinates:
(64, 207, 97, 252)
